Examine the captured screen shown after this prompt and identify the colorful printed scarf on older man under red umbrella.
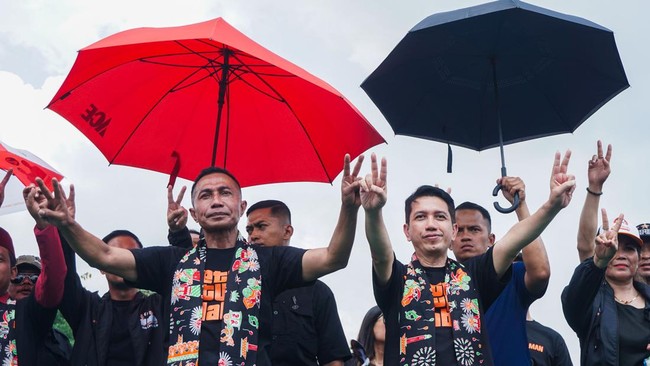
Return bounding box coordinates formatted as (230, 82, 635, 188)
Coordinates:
(167, 236, 262, 366)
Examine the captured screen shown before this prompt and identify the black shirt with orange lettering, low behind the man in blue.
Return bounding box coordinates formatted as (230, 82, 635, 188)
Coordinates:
(526, 320, 573, 366)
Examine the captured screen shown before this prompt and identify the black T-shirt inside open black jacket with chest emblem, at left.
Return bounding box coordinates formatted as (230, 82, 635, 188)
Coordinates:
(106, 300, 135, 366)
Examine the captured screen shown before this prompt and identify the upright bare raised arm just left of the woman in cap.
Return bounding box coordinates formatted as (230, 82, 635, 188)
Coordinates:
(577, 140, 612, 262)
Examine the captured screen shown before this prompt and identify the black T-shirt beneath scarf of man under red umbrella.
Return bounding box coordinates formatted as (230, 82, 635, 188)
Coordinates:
(132, 242, 305, 366)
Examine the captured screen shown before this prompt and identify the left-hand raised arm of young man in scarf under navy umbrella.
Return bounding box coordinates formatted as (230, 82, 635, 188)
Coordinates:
(361, 154, 395, 285)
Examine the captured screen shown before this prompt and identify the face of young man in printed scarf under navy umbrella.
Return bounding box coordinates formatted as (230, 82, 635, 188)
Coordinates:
(404, 196, 457, 264)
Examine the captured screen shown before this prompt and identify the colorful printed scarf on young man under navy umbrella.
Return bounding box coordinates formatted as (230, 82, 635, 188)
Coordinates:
(399, 254, 485, 366)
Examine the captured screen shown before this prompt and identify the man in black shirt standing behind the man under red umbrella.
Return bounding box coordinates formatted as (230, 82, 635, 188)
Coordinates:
(246, 200, 351, 366)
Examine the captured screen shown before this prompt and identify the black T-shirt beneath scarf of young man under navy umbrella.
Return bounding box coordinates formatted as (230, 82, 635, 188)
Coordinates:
(373, 249, 504, 365)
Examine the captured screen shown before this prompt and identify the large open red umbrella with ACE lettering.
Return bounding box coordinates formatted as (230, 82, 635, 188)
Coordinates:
(48, 18, 384, 186)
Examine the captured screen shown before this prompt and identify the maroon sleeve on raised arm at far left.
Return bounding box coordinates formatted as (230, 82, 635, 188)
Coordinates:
(34, 225, 66, 308)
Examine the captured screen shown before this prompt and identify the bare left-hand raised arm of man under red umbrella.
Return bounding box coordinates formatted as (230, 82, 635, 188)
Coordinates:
(33, 178, 137, 281)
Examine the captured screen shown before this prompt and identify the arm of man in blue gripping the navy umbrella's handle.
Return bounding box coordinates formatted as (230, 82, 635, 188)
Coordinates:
(495, 177, 551, 297)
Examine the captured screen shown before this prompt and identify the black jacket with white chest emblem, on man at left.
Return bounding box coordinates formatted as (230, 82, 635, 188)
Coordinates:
(59, 234, 167, 366)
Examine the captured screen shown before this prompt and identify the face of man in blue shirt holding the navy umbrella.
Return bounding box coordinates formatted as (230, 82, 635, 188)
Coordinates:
(451, 209, 494, 262)
